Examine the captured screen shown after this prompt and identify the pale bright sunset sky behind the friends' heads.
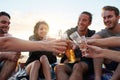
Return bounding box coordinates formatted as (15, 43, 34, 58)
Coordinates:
(0, 0, 120, 39)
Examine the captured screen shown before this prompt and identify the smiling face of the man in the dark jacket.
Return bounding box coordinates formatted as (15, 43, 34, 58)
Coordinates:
(78, 14, 91, 32)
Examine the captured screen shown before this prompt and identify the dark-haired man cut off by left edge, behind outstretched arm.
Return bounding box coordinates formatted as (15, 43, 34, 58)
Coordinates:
(0, 12, 20, 80)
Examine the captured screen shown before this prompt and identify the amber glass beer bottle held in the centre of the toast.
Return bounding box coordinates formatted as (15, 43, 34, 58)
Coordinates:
(65, 40, 76, 63)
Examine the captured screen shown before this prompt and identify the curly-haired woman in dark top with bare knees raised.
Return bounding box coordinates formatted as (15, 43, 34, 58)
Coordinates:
(26, 21, 57, 80)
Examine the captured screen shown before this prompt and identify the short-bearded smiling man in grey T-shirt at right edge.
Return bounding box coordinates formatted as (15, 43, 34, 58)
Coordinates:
(92, 6, 120, 80)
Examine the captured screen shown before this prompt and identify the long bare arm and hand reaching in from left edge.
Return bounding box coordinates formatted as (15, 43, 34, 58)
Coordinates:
(0, 37, 67, 53)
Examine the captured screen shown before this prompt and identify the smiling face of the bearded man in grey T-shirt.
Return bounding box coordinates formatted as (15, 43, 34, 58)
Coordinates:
(102, 10, 119, 30)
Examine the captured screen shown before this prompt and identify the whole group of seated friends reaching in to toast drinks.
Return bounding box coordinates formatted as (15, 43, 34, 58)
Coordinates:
(0, 6, 120, 80)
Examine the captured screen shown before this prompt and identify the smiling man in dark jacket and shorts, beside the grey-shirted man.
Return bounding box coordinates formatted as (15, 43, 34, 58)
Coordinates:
(56, 11, 95, 80)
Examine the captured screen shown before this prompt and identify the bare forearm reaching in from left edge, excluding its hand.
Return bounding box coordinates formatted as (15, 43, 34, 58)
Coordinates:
(0, 37, 44, 51)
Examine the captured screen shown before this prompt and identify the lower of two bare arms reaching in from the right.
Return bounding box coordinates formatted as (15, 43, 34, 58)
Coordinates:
(85, 45, 120, 62)
